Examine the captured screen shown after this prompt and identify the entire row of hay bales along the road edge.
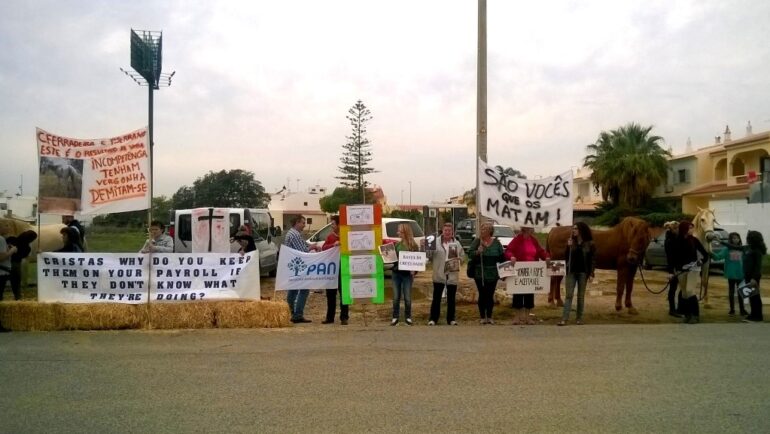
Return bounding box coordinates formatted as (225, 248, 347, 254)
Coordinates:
(0, 300, 290, 331)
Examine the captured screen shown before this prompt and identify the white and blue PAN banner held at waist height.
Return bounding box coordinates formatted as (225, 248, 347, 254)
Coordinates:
(275, 246, 340, 291)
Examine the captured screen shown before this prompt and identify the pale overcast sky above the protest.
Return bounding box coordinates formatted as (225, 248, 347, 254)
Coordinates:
(0, 0, 770, 204)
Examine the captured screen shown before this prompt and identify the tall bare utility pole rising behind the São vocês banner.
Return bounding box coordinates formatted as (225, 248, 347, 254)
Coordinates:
(473, 0, 487, 237)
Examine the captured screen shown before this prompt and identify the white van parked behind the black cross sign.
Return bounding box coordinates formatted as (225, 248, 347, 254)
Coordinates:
(172, 208, 278, 277)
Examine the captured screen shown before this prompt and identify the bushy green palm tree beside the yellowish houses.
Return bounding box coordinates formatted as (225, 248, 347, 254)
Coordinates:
(584, 122, 671, 208)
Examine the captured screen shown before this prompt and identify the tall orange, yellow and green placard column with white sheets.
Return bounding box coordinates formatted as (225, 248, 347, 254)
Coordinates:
(340, 204, 385, 325)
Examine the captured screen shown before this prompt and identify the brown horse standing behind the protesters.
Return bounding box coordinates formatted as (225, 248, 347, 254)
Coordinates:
(546, 217, 650, 315)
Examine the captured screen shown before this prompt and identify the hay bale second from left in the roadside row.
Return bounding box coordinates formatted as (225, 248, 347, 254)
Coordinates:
(58, 303, 145, 330)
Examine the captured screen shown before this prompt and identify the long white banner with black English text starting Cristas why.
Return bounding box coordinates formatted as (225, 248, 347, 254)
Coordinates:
(37, 252, 260, 304)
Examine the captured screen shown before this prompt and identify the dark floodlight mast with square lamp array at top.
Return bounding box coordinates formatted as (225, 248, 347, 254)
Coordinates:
(120, 29, 176, 229)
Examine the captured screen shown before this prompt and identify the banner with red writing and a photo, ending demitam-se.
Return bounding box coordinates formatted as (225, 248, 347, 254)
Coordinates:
(37, 128, 151, 215)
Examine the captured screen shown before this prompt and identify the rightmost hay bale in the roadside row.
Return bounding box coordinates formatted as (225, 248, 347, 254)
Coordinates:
(215, 301, 291, 328)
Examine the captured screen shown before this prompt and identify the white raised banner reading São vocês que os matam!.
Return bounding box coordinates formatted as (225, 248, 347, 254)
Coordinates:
(478, 159, 574, 230)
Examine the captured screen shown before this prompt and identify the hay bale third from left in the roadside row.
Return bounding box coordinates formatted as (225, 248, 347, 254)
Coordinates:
(148, 301, 215, 329)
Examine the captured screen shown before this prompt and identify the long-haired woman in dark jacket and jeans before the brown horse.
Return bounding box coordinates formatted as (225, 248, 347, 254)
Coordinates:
(556, 222, 596, 326)
